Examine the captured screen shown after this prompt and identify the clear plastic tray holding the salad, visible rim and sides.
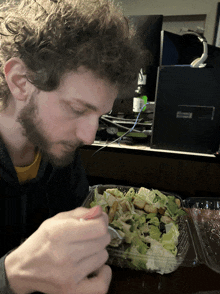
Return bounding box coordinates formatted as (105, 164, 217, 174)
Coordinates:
(83, 185, 192, 274)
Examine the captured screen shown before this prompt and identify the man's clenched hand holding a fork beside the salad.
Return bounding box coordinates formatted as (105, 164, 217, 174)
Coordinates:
(5, 206, 111, 294)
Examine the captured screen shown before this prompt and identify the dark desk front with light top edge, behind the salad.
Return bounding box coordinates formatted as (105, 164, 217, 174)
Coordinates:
(80, 142, 220, 199)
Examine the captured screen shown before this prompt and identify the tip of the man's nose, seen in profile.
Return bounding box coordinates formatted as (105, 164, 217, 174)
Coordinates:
(76, 116, 99, 145)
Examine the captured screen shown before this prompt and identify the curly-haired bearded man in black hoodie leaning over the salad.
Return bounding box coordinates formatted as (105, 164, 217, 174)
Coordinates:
(0, 0, 141, 294)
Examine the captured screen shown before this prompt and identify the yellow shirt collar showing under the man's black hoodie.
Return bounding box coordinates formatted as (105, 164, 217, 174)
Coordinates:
(15, 151, 41, 183)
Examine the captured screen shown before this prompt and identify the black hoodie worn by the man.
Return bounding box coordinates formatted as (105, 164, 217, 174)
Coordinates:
(0, 141, 89, 294)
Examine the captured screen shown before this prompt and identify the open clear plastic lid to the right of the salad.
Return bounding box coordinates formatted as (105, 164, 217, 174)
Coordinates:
(185, 197, 220, 273)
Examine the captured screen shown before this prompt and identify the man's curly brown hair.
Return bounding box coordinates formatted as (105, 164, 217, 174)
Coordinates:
(0, 0, 144, 109)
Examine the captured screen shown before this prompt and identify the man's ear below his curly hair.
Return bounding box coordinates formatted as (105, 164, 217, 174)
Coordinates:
(4, 57, 30, 101)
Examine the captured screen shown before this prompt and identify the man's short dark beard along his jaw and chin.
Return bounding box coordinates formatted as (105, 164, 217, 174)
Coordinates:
(17, 94, 83, 167)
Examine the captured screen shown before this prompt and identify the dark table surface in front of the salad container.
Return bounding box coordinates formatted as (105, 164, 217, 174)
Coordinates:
(108, 265, 220, 294)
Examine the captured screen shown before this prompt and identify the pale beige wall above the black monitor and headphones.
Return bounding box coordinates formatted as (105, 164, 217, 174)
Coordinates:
(115, 0, 220, 44)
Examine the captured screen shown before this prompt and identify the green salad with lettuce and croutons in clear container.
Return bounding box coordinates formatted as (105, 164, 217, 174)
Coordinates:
(90, 187, 186, 274)
